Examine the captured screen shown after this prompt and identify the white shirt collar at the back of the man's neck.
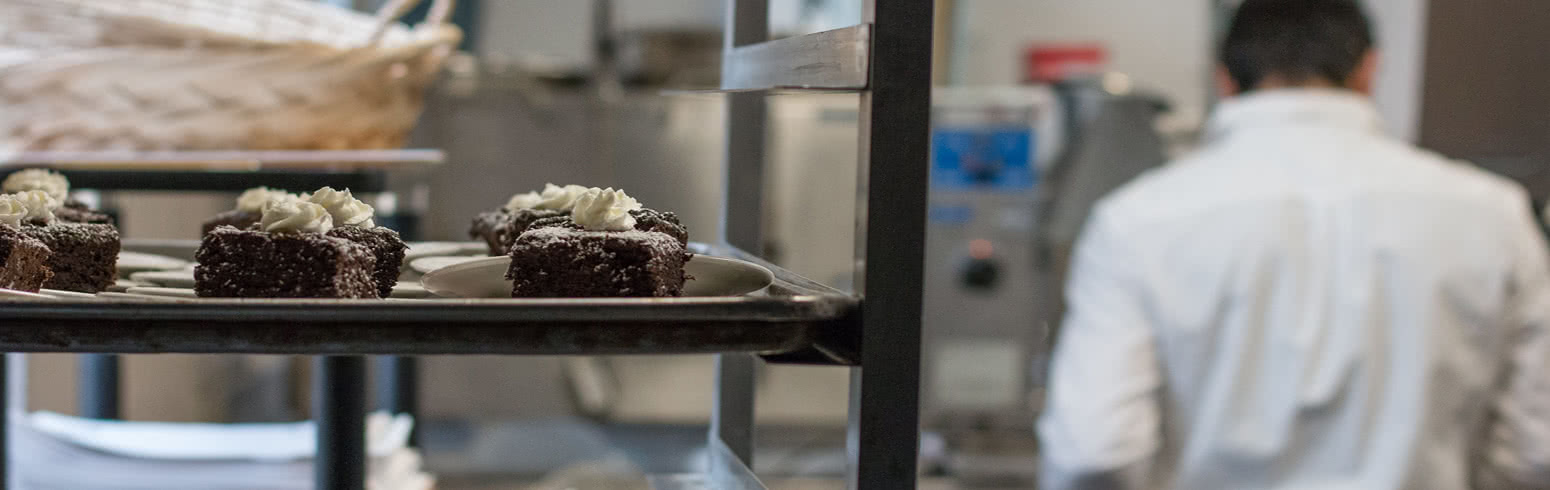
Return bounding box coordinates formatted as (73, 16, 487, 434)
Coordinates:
(1206, 88, 1383, 141)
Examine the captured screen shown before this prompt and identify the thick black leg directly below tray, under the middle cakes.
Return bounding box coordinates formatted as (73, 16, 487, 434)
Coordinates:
(313, 355, 366, 490)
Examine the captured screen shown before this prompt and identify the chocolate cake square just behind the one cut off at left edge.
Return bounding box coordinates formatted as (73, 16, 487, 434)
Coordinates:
(22, 222, 119, 293)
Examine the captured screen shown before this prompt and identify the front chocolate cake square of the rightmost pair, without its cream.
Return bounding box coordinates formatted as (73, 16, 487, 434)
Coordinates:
(505, 226, 690, 298)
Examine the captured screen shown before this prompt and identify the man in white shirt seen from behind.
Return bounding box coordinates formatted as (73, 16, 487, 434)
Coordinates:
(1039, 0, 1550, 490)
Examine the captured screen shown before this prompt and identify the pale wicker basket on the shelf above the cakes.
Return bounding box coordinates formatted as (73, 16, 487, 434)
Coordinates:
(0, 0, 462, 151)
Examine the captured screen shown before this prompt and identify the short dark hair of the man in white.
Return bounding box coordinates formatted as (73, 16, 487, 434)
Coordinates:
(1221, 0, 1373, 91)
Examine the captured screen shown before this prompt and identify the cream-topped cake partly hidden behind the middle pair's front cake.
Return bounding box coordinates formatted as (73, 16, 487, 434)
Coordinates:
(307, 188, 409, 298)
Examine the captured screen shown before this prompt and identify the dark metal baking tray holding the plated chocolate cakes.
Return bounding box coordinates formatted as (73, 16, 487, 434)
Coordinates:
(0, 242, 860, 364)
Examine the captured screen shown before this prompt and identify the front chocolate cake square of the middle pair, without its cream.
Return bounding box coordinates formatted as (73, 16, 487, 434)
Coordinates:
(194, 226, 377, 298)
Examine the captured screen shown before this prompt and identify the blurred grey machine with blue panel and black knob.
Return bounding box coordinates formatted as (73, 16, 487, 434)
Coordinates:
(922, 74, 1166, 485)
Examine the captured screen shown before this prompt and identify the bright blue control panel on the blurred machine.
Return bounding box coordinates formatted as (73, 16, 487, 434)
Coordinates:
(932, 126, 1039, 192)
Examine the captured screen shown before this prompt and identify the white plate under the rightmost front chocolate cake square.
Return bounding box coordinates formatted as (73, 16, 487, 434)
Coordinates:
(420, 256, 775, 298)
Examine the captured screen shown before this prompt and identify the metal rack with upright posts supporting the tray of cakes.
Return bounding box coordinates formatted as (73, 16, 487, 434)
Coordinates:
(0, 0, 933, 490)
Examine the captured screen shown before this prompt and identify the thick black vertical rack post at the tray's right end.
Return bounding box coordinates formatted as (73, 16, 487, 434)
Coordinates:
(848, 0, 933, 490)
